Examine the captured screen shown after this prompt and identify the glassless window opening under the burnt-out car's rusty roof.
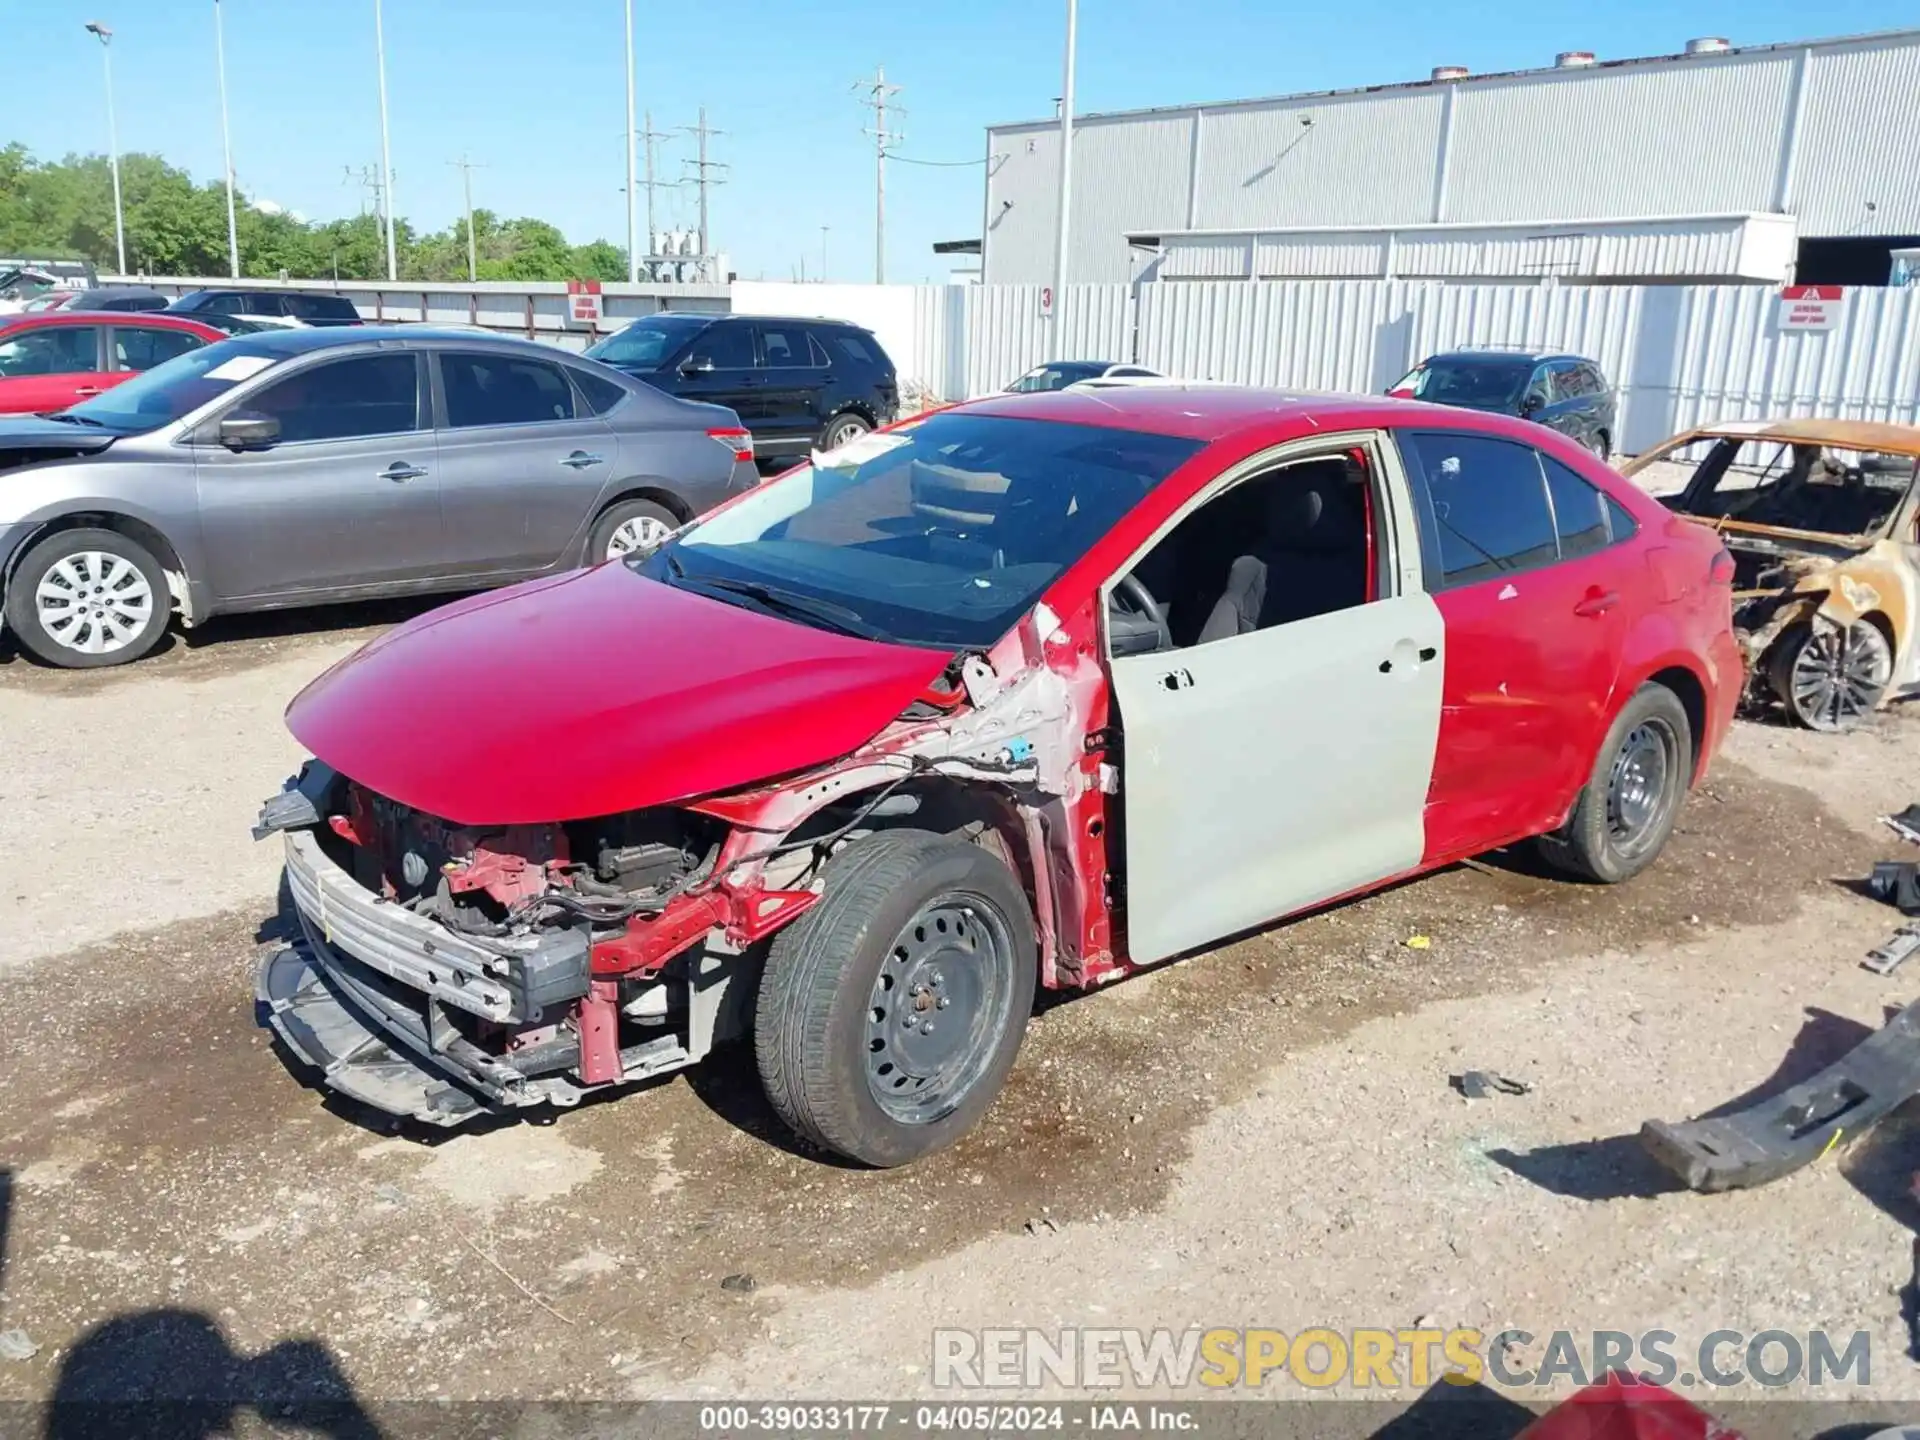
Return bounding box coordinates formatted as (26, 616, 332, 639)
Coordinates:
(1667, 438, 1914, 536)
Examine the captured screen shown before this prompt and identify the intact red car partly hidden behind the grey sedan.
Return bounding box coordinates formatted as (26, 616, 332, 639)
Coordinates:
(0, 309, 227, 415)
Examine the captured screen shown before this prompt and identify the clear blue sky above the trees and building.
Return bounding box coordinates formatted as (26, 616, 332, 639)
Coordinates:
(0, 0, 1914, 280)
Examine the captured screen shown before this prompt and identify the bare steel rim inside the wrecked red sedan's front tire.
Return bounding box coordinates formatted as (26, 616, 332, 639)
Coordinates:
(866, 895, 1014, 1125)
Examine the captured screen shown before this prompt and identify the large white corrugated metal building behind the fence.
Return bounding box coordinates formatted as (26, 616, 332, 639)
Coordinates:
(983, 31, 1920, 284)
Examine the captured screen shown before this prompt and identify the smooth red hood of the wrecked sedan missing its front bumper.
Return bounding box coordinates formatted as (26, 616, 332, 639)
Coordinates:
(286, 564, 952, 826)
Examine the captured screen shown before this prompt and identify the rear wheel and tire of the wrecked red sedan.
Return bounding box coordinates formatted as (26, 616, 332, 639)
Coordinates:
(1540, 684, 1693, 885)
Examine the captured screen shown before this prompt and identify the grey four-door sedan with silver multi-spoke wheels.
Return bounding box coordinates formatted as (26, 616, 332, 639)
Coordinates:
(0, 317, 758, 666)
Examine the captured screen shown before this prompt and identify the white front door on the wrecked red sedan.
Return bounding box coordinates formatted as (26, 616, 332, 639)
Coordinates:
(1110, 436, 1446, 964)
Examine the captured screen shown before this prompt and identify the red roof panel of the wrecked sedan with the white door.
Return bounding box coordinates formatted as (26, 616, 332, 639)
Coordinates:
(947, 380, 1542, 444)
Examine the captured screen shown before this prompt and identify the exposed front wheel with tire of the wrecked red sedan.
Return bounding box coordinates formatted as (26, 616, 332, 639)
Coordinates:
(753, 829, 1037, 1167)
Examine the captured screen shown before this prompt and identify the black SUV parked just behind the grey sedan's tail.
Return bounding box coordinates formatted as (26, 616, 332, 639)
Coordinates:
(588, 311, 900, 459)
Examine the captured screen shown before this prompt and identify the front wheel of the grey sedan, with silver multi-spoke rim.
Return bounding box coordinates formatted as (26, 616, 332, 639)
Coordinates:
(6, 530, 173, 670)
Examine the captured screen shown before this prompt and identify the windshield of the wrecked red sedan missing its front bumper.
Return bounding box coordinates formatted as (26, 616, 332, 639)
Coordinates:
(641, 413, 1200, 649)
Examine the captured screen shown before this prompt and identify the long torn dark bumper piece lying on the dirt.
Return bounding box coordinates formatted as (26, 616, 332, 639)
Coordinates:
(1640, 1000, 1920, 1194)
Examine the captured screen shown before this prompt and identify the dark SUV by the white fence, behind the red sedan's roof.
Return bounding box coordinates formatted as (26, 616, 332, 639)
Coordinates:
(1388, 349, 1620, 459)
